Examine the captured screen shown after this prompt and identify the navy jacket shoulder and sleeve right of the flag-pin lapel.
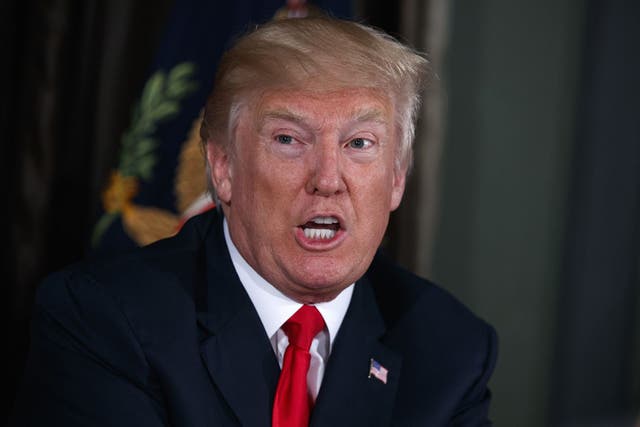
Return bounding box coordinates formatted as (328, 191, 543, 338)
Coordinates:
(369, 252, 497, 425)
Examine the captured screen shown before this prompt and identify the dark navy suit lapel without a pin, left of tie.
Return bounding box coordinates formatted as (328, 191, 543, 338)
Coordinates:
(198, 216, 280, 427)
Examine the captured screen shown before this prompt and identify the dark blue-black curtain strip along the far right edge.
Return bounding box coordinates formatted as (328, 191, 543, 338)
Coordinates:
(550, 0, 640, 426)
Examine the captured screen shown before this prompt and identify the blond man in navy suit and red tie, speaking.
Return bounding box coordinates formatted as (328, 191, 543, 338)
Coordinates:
(16, 18, 496, 426)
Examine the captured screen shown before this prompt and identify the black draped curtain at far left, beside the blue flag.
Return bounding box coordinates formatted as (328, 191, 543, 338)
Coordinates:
(0, 0, 172, 414)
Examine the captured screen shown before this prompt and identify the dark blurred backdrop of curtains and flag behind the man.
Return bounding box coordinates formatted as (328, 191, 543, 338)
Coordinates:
(0, 0, 640, 427)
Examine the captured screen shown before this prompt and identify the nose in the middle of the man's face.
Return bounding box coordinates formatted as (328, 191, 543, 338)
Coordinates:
(307, 140, 346, 197)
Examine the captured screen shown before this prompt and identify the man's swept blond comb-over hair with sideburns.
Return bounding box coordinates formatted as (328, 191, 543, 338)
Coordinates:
(200, 17, 429, 176)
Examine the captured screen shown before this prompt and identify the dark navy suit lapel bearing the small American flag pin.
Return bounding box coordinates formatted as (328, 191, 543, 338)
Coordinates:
(310, 279, 402, 427)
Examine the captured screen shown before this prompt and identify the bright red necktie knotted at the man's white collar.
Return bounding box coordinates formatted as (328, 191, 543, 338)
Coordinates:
(272, 305, 324, 427)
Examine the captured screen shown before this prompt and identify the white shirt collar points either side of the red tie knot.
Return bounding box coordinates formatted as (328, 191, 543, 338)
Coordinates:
(223, 218, 353, 347)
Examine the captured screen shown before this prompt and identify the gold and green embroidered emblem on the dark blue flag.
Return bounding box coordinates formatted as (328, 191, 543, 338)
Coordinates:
(92, 62, 206, 246)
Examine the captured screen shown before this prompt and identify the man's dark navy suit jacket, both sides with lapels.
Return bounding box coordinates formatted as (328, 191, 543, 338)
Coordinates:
(13, 212, 496, 427)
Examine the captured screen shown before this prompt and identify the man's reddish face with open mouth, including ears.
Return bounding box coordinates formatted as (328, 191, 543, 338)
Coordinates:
(208, 88, 405, 303)
